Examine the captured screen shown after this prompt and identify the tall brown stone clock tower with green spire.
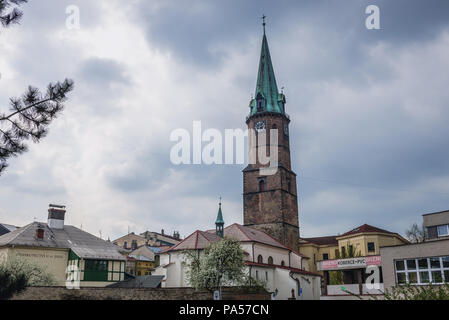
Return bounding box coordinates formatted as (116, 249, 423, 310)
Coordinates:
(243, 20, 299, 250)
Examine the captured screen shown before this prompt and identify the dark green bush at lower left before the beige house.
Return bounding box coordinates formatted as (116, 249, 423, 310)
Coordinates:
(0, 259, 56, 300)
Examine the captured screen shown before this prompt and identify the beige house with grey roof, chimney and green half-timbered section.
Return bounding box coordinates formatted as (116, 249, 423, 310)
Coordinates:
(0, 206, 126, 287)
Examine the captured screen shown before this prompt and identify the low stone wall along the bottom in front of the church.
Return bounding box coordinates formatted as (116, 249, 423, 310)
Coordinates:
(12, 287, 270, 300)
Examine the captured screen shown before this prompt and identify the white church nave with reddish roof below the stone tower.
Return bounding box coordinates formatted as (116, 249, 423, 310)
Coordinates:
(153, 223, 321, 300)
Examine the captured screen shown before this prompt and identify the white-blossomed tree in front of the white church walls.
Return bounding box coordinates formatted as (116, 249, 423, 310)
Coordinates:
(184, 238, 248, 290)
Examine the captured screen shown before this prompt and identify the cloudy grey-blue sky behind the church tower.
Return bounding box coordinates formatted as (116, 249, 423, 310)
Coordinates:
(0, 0, 449, 239)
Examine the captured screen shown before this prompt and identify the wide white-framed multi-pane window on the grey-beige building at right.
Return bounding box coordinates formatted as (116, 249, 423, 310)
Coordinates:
(395, 256, 449, 284)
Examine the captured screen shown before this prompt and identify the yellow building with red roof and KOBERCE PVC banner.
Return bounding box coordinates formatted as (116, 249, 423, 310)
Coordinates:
(299, 224, 408, 296)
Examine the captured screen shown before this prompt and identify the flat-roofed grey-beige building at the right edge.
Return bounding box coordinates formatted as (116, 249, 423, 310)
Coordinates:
(381, 211, 449, 289)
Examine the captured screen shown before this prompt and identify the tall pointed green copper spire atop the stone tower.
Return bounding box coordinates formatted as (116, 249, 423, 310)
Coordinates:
(250, 16, 285, 116)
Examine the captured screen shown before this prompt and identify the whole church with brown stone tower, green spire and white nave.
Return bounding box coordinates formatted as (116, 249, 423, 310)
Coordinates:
(153, 22, 321, 300)
